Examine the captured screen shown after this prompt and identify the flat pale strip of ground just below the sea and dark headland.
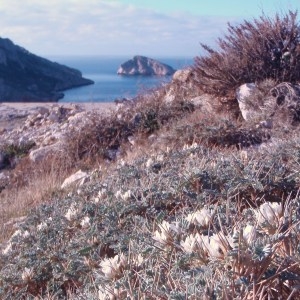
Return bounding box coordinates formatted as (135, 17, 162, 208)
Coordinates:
(0, 102, 116, 132)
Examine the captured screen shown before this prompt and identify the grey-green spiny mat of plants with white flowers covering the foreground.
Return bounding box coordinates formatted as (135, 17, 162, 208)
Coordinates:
(0, 131, 300, 299)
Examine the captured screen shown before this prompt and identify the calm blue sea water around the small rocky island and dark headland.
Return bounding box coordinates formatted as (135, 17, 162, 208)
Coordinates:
(49, 56, 193, 102)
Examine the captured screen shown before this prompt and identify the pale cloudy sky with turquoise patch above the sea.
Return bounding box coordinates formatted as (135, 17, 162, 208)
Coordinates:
(0, 0, 300, 57)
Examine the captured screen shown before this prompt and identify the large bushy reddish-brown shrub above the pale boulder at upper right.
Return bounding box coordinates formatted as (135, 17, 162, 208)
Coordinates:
(195, 11, 300, 99)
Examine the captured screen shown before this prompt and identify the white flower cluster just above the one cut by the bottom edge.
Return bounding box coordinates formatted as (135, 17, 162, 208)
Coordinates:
(100, 253, 126, 279)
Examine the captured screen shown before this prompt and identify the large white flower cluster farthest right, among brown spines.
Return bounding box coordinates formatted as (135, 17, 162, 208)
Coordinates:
(254, 202, 283, 233)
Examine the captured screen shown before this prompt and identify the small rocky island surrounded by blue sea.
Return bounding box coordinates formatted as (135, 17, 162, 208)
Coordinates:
(117, 55, 176, 76)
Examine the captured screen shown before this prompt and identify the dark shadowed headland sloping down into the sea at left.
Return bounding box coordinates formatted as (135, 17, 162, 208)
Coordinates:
(0, 38, 93, 102)
